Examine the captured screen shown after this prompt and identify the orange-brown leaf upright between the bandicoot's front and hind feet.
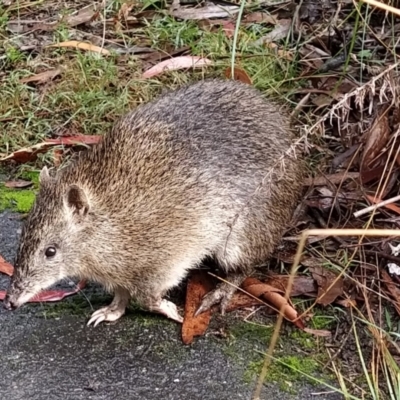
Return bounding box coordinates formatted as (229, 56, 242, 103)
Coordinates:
(182, 271, 214, 344)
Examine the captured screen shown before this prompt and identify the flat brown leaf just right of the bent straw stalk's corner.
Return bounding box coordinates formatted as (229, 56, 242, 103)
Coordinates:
(309, 267, 343, 306)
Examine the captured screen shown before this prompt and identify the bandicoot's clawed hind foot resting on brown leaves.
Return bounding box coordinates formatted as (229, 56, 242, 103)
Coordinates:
(195, 272, 246, 316)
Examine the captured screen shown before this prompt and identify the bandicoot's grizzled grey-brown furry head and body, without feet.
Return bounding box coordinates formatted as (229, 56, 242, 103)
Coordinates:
(7, 80, 302, 308)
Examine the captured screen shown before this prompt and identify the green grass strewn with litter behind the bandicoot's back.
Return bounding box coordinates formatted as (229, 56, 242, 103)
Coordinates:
(0, 14, 296, 160)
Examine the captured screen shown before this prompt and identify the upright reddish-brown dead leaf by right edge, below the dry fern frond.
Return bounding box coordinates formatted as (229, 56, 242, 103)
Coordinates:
(361, 111, 390, 170)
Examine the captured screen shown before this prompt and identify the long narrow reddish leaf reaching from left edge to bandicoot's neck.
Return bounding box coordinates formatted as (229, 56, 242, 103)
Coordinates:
(0, 135, 102, 163)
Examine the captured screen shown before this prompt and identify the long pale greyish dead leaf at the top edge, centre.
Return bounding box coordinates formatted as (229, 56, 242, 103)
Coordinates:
(169, 2, 239, 20)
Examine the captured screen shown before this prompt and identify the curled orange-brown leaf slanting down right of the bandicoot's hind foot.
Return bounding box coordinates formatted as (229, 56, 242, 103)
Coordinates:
(242, 278, 304, 329)
